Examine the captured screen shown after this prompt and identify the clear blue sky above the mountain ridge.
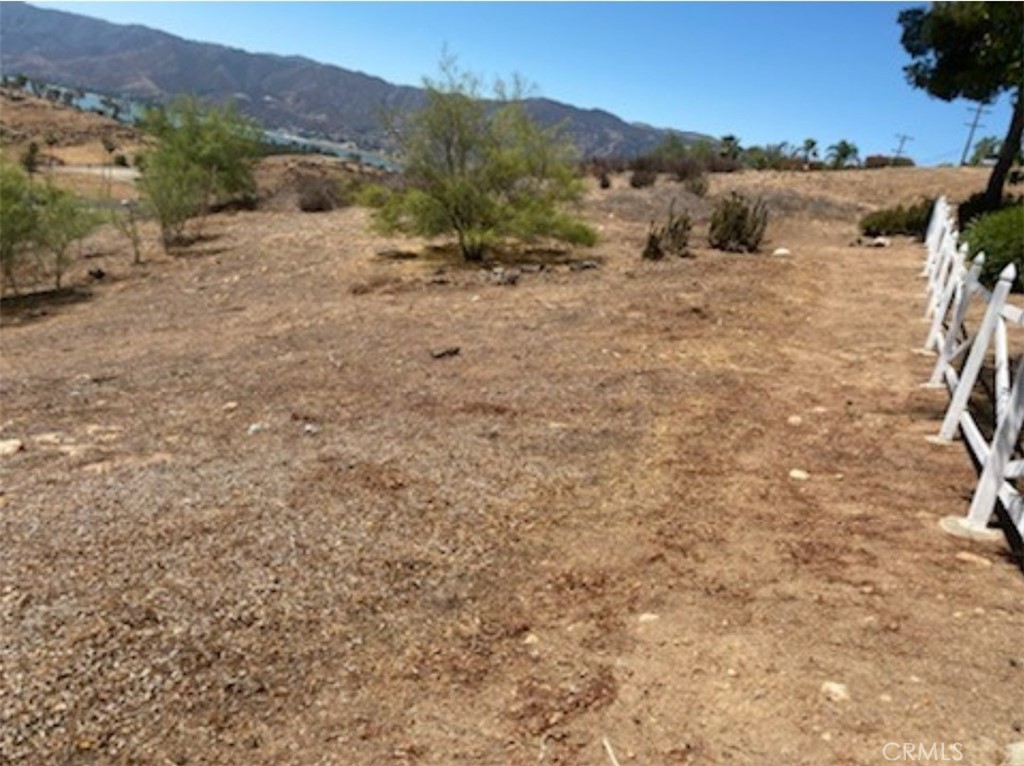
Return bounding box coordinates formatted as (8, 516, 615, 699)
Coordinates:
(34, 2, 1010, 165)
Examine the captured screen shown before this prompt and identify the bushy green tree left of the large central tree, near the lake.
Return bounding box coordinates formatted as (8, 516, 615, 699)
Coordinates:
(140, 98, 260, 248)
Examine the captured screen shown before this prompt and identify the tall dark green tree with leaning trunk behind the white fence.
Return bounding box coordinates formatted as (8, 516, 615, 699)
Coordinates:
(899, 2, 1024, 208)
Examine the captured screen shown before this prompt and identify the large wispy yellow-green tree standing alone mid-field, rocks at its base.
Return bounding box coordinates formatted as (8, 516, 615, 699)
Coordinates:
(376, 55, 596, 261)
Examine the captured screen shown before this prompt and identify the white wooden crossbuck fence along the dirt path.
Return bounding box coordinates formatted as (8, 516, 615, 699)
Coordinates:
(924, 198, 1024, 568)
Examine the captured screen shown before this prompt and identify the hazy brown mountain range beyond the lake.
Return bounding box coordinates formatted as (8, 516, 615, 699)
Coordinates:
(0, 2, 710, 157)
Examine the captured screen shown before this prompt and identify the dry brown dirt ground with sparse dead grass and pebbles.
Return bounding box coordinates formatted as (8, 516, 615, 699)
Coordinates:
(0, 162, 1024, 766)
